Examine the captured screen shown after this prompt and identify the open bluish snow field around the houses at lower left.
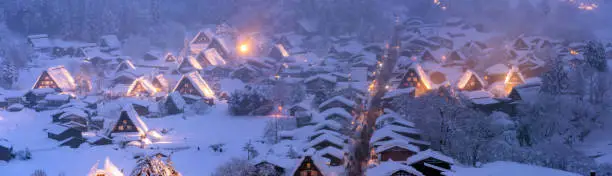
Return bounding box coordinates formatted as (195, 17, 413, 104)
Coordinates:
(0, 104, 268, 176)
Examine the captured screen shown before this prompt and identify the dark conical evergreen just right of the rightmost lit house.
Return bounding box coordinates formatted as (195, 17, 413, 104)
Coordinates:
(540, 57, 568, 95)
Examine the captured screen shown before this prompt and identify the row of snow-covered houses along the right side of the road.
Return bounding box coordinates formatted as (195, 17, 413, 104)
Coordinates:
(366, 110, 454, 176)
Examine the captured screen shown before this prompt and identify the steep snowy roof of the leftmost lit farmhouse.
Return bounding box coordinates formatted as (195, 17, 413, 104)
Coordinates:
(33, 66, 76, 92)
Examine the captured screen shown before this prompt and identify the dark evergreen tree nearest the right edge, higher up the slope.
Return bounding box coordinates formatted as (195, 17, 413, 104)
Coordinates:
(584, 41, 608, 72)
